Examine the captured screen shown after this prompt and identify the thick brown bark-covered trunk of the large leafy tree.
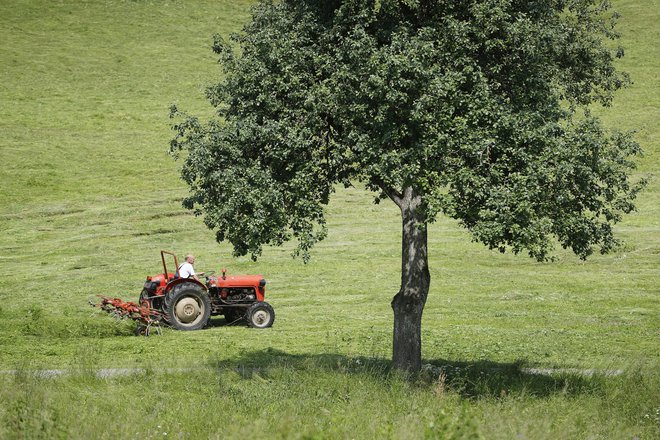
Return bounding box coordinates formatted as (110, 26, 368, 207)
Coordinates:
(392, 188, 431, 372)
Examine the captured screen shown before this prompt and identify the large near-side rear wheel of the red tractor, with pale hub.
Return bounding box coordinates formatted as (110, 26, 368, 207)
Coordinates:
(165, 283, 211, 330)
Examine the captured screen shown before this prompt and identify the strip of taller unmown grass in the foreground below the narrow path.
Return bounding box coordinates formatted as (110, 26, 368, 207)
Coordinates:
(0, 360, 659, 439)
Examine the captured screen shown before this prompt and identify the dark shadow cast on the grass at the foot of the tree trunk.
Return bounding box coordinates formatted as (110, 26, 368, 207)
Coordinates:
(211, 349, 611, 399)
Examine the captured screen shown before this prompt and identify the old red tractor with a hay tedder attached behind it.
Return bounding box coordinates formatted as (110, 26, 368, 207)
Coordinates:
(91, 251, 275, 336)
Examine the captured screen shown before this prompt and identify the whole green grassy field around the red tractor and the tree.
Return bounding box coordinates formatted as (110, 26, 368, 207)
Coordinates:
(0, 0, 660, 439)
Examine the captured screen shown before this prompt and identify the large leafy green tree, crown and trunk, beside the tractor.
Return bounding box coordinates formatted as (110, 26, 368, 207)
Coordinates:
(171, 0, 644, 371)
